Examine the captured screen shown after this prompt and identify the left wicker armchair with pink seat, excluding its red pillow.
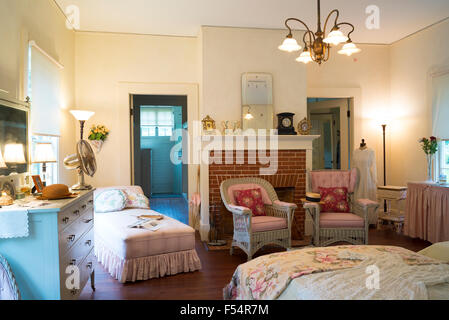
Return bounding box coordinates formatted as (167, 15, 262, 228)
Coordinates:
(220, 178, 297, 261)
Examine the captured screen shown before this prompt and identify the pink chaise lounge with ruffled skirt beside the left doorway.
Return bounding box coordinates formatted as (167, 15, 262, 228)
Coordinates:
(94, 186, 201, 283)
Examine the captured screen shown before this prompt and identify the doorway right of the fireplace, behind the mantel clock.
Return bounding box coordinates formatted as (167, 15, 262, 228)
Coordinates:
(307, 98, 354, 170)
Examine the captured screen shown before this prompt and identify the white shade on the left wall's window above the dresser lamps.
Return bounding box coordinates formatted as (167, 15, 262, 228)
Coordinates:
(28, 41, 62, 136)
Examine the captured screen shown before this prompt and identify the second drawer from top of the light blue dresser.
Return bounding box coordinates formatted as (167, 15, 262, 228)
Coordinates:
(59, 208, 94, 256)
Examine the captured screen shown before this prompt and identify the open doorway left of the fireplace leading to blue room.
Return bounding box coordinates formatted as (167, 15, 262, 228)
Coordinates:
(132, 95, 188, 204)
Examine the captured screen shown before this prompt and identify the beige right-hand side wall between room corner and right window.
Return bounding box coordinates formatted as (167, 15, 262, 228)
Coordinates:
(389, 20, 449, 184)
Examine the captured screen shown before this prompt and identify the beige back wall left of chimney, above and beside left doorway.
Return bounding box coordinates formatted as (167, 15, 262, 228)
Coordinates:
(75, 32, 199, 187)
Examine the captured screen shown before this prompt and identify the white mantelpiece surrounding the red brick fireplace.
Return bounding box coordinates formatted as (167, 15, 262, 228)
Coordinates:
(197, 135, 320, 241)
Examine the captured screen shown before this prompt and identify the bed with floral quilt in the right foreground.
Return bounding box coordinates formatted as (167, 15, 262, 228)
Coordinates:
(224, 246, 449, 300)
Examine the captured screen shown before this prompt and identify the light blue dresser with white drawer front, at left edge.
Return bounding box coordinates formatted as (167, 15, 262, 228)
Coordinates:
(0, 190, 96, 300)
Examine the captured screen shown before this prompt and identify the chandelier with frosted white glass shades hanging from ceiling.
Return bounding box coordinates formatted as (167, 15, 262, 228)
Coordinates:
(279, 0, 361, 65)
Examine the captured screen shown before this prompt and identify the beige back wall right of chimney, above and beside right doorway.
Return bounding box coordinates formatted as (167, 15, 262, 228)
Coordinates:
(307, 45, 390, 182)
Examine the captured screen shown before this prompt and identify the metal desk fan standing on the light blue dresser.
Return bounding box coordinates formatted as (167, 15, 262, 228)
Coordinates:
(64, 140, 97, 190)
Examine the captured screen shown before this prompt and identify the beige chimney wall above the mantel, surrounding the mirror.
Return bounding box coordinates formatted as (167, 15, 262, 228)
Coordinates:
(201, 27, 307, 124)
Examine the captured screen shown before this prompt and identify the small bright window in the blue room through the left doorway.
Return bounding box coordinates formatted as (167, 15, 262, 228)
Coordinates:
(140, 107, 175, 137)
